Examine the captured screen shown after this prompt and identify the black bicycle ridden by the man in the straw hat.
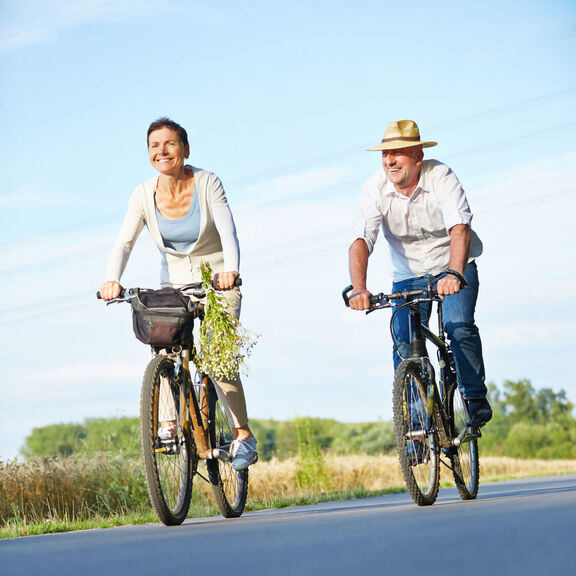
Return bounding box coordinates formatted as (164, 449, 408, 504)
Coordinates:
(342, 276, 481, 506)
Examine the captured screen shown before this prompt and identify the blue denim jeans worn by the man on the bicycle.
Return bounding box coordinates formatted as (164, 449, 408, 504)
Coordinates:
(392, 262, 487, 400)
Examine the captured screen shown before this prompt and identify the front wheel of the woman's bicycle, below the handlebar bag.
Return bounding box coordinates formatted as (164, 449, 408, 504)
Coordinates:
(140, 356, 197, 526)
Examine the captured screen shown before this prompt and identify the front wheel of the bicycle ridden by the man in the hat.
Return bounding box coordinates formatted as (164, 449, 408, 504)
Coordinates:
(393, 360, 440, 506)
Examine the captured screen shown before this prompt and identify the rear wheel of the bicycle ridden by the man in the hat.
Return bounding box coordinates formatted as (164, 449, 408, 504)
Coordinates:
(449, 386, 480, 500)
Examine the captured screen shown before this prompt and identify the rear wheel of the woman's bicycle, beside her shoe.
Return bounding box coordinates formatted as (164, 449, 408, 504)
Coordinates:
(204, 377, 248, 518)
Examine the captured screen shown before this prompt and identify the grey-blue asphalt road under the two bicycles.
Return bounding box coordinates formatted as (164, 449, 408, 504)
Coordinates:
(0, 475, 576, 576)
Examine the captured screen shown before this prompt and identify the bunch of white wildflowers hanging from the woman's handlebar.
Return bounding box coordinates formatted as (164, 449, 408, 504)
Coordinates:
(198, 262, 257, 380)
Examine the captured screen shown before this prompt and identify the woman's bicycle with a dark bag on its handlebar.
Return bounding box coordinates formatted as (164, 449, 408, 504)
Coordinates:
(98, 278, 248, 526)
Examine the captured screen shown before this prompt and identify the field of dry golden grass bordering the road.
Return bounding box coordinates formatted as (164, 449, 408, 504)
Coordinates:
(0, 453, 576, 537)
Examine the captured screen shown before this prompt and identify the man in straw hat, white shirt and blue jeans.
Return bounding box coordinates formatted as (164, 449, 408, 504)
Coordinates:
(349, 120, 492, 427)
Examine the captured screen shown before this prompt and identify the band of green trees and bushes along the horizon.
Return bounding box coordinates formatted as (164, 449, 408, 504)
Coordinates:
(21, 379, 576, 460)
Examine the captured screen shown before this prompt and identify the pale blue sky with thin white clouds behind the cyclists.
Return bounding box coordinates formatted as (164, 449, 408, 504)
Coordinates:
(0, 0, 576, 458)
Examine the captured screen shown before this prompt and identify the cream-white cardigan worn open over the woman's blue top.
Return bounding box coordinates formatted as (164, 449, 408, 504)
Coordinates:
(105, 166, 240, 286)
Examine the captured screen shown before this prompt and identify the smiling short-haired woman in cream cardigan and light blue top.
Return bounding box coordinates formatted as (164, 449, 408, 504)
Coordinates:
(100, 118, 257, 470)
